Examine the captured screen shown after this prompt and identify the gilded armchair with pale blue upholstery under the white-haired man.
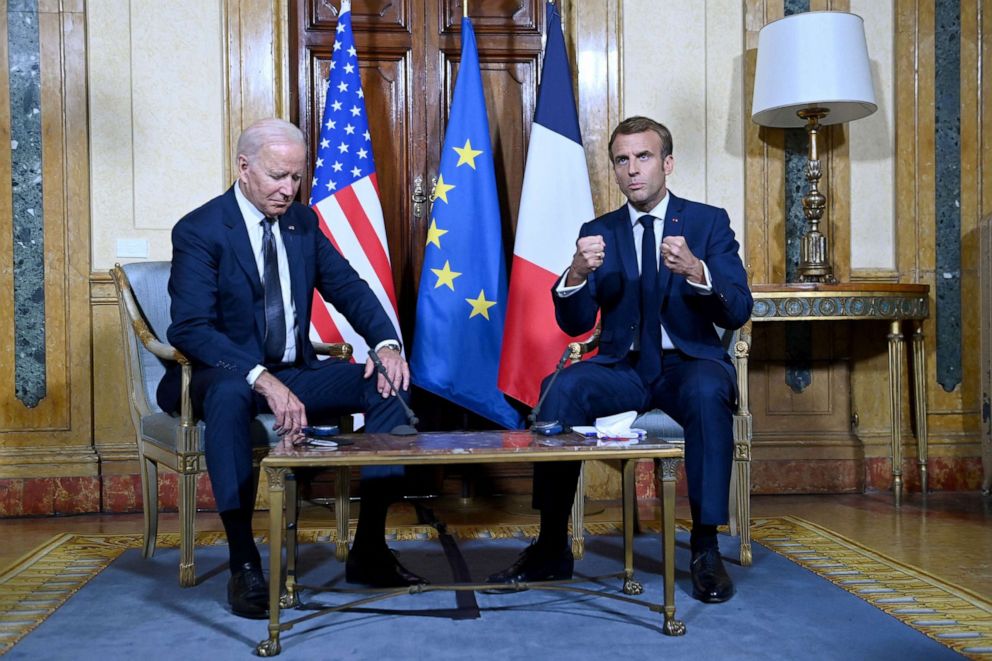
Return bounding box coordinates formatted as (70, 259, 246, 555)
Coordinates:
(110, 262, 352, 587)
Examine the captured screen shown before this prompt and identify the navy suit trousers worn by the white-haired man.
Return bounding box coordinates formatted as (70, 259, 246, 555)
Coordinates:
(190, 359, 406, 512)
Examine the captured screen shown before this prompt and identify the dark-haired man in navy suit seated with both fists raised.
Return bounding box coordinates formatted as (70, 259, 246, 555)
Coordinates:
(489, 117, 753, 602)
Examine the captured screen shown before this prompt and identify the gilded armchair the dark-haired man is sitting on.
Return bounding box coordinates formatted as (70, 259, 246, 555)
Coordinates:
(569, 321, 752, 566)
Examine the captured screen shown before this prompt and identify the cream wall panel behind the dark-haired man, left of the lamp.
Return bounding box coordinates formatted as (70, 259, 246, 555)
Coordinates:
(623, 0, 744, 242)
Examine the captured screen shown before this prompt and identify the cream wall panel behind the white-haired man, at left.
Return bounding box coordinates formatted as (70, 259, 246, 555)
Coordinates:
(87, 0, 227, 271)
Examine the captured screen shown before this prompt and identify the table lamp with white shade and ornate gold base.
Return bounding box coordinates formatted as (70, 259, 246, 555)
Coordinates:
(751, 11, 878, 282)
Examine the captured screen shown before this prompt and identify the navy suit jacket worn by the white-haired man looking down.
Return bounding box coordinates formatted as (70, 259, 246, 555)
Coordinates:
(159, 183, 396, 410)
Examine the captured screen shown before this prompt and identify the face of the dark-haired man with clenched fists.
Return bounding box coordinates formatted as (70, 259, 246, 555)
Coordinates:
(611, 131, 675, 211)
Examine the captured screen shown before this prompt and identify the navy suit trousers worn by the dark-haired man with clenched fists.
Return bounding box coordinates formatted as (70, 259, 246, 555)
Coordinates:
(533, 351, 737, 525)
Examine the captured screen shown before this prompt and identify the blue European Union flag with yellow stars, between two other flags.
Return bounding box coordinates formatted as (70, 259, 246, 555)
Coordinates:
(410, 18, 522, 429)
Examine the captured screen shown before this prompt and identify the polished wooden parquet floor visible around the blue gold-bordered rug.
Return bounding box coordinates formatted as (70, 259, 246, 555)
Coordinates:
(0, 492, 992, 597)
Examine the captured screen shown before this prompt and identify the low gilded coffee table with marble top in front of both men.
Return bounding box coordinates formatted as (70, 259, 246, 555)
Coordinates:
(256, 431, 685, 656)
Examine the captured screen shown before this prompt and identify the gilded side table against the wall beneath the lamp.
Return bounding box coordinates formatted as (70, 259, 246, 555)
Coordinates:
(751, 283, 930, 505)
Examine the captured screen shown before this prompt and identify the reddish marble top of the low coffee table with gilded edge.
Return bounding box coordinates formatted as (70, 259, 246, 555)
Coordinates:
(262, 431, 684, 468)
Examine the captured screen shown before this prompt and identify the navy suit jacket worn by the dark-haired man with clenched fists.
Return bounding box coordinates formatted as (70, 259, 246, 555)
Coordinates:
(552, 192, 754, 371)
